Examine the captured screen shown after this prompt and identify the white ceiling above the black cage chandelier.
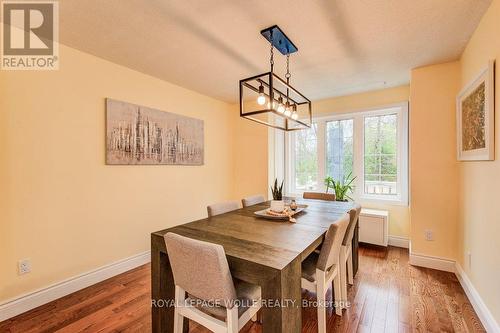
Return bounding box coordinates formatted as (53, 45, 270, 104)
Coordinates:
(56, 0, 491, 102)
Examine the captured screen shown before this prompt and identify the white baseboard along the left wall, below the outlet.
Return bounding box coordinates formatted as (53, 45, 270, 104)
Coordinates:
(0, 251, 151, 321)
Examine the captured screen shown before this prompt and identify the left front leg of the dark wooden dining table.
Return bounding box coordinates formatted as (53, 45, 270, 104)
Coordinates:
(151, 239, 189, 333)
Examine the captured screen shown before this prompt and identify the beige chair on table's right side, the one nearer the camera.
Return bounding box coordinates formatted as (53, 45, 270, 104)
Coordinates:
(301, 214, 349, 333)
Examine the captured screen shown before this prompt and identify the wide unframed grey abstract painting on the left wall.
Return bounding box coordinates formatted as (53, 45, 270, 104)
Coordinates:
(106, 98, 204, 165)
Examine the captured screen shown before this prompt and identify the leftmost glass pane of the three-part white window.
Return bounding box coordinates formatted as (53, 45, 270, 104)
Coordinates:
(294, 124, 318, 191)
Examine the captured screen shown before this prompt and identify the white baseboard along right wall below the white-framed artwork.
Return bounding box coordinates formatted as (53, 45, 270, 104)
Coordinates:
(455, 262, 500, 333)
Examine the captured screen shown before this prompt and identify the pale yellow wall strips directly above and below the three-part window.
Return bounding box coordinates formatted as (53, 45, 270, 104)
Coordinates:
(313, 85, 410, 237)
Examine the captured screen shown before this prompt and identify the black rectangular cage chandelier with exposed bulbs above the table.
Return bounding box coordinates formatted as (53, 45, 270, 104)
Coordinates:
(240, 25, 312, 131)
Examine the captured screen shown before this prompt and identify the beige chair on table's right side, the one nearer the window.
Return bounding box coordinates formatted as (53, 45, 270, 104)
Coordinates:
(340, 205, 361, 301)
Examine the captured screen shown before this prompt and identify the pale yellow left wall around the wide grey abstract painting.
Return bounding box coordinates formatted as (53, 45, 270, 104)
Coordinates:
(0, 46, 234, 301)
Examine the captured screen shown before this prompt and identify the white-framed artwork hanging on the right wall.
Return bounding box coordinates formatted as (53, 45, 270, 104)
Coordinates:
(457, 61, 495, 161)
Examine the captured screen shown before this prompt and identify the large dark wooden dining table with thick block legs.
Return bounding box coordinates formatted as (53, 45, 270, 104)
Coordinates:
(151, 199, 358, 333)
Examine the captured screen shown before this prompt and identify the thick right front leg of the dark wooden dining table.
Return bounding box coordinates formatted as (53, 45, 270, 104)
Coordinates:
(261, 258, 302, 333)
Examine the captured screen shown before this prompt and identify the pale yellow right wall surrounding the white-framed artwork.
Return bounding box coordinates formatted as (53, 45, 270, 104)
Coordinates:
(458, 0, 500, 323)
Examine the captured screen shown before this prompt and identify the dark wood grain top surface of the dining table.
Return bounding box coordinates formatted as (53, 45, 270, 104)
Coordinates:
(152, 199, 354, 270)
